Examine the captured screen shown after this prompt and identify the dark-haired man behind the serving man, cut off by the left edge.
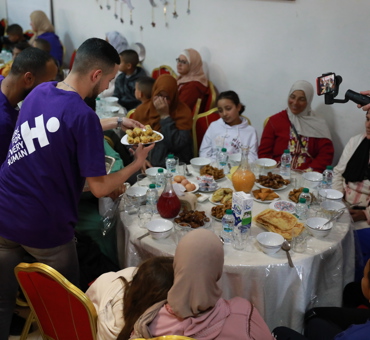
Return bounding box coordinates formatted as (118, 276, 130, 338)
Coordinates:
(0, 48, 58, 166)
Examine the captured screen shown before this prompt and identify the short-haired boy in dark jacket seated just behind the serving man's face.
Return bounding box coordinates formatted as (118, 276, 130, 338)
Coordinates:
(113, 50, 146, 111)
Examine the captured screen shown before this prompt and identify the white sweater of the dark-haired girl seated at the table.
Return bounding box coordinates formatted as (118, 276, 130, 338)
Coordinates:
(199, 117, 258, 163)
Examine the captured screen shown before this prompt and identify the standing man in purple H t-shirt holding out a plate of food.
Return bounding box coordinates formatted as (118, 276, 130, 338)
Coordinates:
(0, 38, 154, 340)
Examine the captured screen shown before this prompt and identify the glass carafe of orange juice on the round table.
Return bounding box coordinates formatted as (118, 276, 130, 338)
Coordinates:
(231, 146, 256, 193)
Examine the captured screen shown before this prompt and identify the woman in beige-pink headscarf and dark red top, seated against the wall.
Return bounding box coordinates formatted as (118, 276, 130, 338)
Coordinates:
(176, 48, 208, 112)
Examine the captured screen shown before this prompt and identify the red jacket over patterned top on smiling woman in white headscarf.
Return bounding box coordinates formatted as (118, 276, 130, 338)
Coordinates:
(258, 110, 334, 172)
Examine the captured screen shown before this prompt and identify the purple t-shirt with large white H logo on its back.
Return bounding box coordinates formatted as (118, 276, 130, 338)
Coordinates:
(0, 82, 106, 248)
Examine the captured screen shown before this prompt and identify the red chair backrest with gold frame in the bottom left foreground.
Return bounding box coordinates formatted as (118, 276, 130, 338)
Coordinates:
(14, 263, 97, 340)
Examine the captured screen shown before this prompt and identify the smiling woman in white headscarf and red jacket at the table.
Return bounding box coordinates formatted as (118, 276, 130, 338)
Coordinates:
(258, 80, 334, 172)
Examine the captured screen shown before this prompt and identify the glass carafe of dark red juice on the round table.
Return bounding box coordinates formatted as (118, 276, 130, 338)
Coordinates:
(157, 173, 181, 218)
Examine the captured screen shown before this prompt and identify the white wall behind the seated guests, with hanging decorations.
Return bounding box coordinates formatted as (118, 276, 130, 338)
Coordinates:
(0, 0, 370, 162)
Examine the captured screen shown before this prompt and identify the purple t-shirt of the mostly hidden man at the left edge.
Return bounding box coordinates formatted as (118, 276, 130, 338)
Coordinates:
(0, 76, 19, 166)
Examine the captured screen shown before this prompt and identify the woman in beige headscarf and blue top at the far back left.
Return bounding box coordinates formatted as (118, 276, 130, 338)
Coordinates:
(30, 11, 63, 67)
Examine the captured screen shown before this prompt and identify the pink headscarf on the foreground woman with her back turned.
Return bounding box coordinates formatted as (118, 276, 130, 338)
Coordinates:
(168, 229, 224, 319)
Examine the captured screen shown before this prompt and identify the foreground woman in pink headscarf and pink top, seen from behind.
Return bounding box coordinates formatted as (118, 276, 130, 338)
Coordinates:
(131, 229, 273, 340)
